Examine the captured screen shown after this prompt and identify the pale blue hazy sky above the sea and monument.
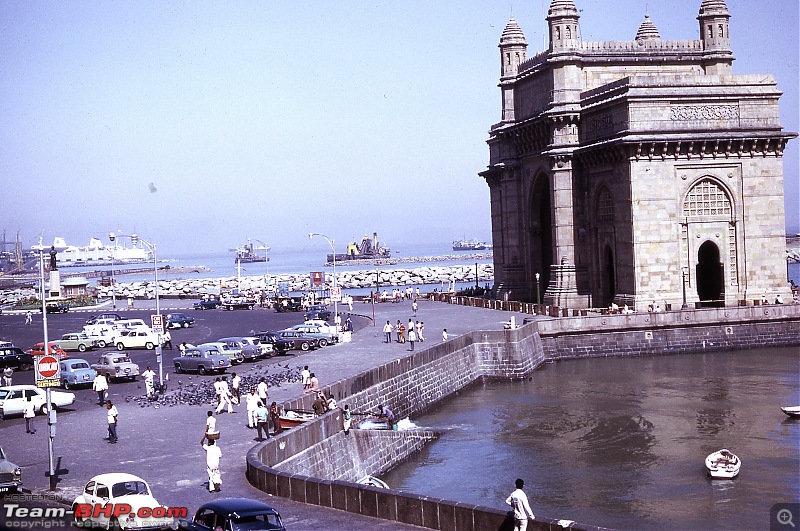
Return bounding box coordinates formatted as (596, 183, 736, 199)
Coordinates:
(0, 0, 800, 256)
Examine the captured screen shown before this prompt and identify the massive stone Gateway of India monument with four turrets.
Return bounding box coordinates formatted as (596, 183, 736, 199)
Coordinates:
(480, 0, 797, 311)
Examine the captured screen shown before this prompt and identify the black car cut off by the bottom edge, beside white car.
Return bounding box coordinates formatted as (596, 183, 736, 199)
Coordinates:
(181, 498, 286, 531)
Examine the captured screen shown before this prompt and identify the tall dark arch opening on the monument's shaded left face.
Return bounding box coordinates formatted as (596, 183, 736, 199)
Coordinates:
(530, 173, 553, 302)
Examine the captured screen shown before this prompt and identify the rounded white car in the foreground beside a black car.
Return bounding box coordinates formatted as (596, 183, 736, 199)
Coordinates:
(72, 472, 177, 530)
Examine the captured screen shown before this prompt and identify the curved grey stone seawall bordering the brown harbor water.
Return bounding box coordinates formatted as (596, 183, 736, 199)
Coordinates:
(247, 304, 800, 531)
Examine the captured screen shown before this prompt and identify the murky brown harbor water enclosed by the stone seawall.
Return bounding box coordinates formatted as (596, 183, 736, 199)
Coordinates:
(381, 348, 800, 529)
